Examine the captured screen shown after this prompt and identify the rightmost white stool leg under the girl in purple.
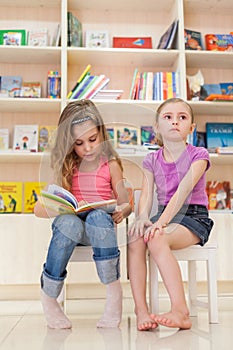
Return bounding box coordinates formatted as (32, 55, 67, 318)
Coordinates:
(206, 250, 218, 323)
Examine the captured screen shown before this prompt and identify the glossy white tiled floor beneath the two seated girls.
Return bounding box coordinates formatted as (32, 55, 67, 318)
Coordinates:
(0, 296, 233, 350)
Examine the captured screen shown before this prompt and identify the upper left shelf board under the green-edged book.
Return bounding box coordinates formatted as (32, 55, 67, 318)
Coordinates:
(0, 46, 61, 64)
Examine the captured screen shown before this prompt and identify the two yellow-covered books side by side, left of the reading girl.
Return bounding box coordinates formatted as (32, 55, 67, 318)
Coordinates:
(0, 181, 46, 214)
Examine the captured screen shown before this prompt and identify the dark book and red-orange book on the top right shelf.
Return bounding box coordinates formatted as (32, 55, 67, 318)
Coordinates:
(184, 28, 233, 51)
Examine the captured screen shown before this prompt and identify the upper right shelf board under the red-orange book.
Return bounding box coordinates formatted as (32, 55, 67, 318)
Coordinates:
(185, 50, 233, 69)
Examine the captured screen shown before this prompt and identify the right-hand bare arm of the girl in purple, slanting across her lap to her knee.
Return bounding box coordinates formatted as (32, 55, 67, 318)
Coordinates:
(147, 159, 207, 236)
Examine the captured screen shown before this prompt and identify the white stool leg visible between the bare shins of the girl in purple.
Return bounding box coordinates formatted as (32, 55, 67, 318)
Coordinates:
(149, 255, 159, 314)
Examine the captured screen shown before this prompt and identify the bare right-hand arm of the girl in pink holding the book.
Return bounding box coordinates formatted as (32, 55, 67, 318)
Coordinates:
(109, 160, 132, 224)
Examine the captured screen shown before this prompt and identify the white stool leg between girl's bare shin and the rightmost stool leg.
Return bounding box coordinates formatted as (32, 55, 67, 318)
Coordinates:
(188, 260, 197, 316)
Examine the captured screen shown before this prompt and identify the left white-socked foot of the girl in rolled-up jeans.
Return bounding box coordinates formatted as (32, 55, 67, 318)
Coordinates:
(41, 290, 72, 329)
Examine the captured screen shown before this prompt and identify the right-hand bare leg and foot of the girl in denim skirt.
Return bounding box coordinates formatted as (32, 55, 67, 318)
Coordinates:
(148, 225, 198, 329)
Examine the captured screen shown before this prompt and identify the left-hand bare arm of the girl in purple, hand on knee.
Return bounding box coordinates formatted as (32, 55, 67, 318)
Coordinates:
(129, 169, 154, 236)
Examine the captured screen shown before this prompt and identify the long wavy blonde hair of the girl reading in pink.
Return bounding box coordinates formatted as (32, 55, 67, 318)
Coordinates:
(51, 100, 122, 190)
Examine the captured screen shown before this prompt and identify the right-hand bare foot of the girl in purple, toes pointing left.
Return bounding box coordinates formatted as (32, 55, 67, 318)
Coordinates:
(154, 311, 192, 329)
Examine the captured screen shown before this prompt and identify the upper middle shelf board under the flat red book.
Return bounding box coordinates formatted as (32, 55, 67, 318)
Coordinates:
(67, 47, 179, 68)
